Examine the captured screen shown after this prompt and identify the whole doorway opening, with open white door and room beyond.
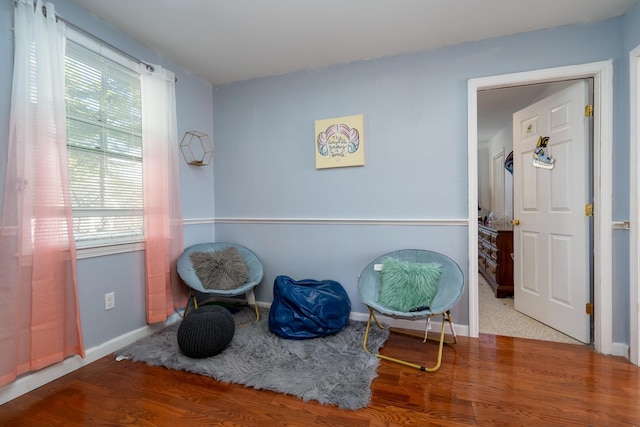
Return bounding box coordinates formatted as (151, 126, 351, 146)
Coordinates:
(478, 79, 592, 344)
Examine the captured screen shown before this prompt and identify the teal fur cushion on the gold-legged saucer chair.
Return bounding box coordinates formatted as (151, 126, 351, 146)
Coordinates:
(378, 258, 442, 312)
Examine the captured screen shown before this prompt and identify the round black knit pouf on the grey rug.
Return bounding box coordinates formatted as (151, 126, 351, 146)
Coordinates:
(178, 305, 236, 359)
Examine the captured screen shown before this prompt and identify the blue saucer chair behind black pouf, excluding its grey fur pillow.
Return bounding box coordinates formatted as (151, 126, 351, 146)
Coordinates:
(177, 242, 263, 320)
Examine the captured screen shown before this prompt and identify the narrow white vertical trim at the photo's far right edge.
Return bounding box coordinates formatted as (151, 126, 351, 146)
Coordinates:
(629, 46, 640, 365)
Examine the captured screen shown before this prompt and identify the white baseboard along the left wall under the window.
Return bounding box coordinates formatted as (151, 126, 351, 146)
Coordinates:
(0, 313, 180, 405)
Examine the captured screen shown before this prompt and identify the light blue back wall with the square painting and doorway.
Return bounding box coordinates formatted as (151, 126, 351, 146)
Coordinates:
(213, 18, 628, 334)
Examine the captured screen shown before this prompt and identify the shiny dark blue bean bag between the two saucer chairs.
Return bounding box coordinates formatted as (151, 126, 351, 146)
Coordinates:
(269, 276, 351, 339)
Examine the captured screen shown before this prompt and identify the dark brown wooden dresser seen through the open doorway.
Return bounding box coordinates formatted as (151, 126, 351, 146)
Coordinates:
(478, 224, 513, 298)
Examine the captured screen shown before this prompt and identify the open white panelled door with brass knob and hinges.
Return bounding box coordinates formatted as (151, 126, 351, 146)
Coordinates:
(513, 81, 591, 343)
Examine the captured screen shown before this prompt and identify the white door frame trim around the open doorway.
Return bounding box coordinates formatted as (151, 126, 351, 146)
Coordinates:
(467, 59, 613, 354)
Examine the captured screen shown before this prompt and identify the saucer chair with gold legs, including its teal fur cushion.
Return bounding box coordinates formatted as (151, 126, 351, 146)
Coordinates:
(358, 249, 464, 372)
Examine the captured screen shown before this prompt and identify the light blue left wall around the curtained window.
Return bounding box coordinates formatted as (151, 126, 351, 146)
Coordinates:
(0, 0, 215, 348)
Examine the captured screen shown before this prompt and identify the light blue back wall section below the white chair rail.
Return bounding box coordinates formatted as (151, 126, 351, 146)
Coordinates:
(216, 224, 468, 324)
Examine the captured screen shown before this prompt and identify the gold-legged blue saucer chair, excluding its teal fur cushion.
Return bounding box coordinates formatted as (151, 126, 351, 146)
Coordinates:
(358, 249, 464, 372)
